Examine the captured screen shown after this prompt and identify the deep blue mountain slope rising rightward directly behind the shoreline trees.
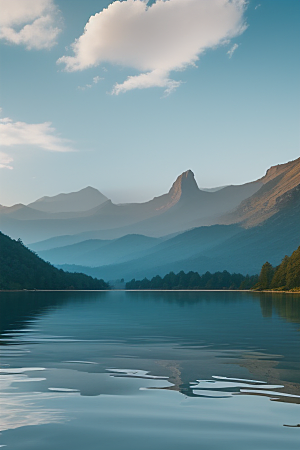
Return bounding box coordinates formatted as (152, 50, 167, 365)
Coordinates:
(58, 186, 300, 281)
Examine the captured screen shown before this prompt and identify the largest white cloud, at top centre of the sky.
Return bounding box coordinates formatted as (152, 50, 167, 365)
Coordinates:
(57, 0, 247, 94)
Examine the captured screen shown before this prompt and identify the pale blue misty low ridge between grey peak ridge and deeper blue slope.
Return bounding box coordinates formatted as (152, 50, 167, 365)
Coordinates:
(38, 225, 240, 267)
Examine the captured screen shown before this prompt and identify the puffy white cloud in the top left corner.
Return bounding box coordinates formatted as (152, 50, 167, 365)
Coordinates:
(0, 0, 62, 50)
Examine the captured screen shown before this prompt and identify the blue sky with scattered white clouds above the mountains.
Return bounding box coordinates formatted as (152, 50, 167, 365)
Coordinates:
(0, 0, 300, 206)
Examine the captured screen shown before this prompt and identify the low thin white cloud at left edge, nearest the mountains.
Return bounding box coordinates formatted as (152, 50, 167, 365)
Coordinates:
(0, 117, 73, 157)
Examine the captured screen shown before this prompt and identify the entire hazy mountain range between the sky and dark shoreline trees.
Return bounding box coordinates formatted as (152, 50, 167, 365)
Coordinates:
(0, 158, 300, 280)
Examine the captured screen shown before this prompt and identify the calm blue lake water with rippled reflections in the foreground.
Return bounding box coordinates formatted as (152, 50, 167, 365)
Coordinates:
(0, 292, 300, 450)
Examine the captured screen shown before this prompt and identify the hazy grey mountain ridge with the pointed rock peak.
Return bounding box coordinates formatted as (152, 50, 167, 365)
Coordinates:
(0, 170, 262, 245)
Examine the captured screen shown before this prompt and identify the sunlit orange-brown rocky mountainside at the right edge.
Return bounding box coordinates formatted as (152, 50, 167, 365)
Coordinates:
(220, 158, 300, 228)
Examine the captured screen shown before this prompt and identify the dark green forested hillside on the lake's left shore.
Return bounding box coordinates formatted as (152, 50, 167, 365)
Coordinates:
(0, 233, 108, 290)
